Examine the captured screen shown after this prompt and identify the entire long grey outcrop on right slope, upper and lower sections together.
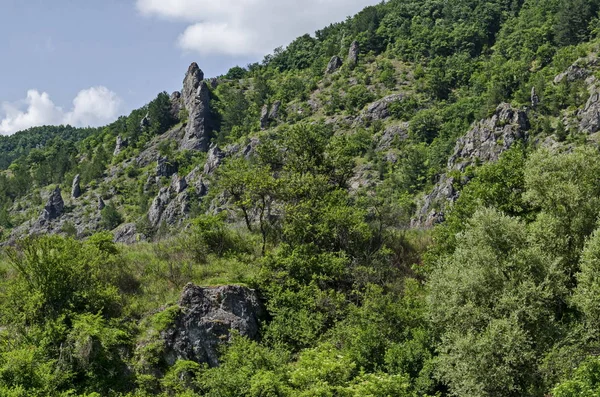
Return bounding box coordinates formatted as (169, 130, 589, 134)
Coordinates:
(412, 103, 529, 227)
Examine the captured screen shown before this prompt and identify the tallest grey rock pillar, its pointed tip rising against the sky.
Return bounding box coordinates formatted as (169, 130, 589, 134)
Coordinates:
(181, 62, 211, 151)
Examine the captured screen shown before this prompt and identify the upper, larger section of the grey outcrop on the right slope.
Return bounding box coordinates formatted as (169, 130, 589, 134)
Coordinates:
(448, 103, 529, 171)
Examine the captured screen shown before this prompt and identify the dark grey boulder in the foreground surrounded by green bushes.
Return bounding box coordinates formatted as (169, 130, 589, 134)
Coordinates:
(161, 284, 266, 366)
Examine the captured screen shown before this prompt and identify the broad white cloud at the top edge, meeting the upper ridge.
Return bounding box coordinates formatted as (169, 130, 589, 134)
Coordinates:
(137, 0, 380, 56)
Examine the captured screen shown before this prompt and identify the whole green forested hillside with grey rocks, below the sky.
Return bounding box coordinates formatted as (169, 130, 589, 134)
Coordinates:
(0, 0, 600, 397)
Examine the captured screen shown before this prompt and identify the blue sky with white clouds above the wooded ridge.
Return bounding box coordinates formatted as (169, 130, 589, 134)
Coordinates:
(0, 0, 379, 134)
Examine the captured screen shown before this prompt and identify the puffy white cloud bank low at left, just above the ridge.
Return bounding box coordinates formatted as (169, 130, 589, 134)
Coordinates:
(0, 87, 123, 135)
